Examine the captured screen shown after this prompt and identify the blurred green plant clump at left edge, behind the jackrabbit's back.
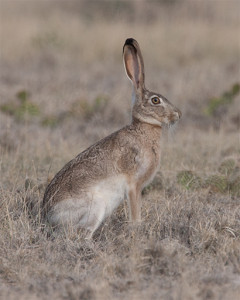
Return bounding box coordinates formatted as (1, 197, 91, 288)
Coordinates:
(0, 90, 40, 121)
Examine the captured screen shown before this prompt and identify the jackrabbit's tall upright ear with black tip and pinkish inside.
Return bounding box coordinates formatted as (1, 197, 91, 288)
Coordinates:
(123, 38, 144, 90)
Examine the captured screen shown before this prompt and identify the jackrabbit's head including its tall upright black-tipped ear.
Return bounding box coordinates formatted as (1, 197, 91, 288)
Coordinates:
(123, 38, 181, 126)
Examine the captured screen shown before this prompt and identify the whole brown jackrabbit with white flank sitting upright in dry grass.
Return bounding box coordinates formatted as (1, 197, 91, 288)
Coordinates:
(42, 38, 181, 238)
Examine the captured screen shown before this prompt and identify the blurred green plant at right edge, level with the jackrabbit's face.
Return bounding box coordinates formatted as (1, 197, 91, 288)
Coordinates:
(204, 83, 240, 116)
